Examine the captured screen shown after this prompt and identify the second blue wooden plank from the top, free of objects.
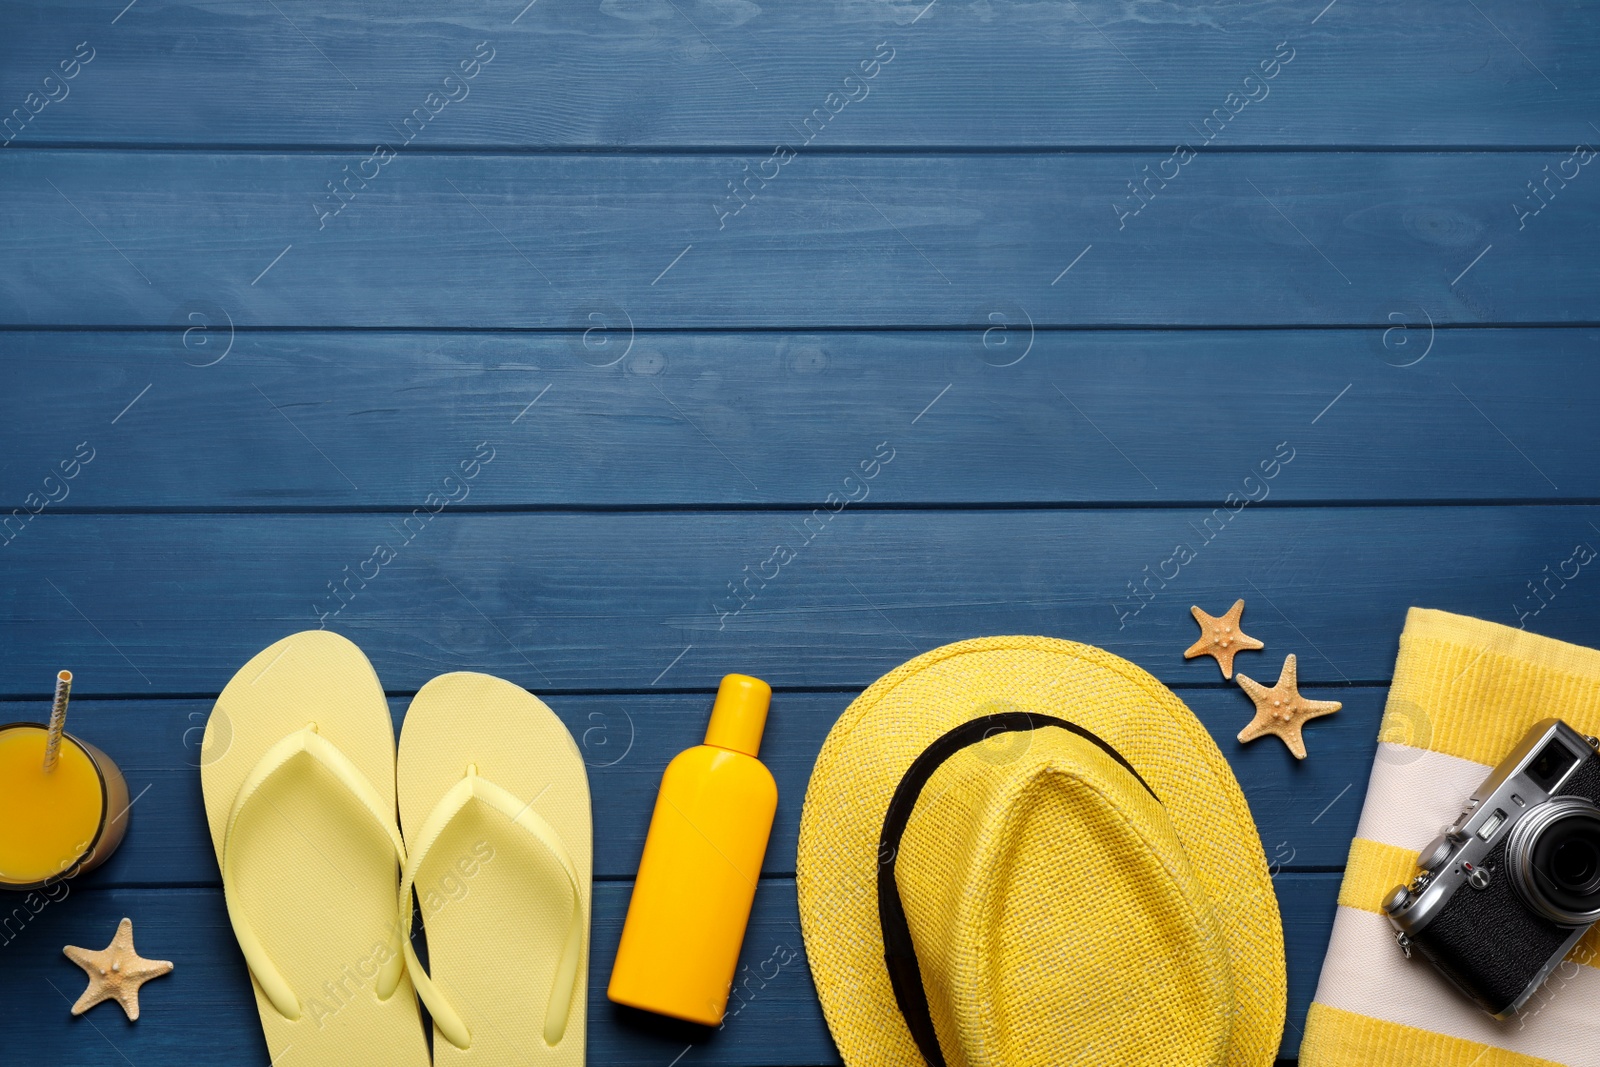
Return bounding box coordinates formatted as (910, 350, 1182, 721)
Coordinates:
(0, 152, 1600, 330)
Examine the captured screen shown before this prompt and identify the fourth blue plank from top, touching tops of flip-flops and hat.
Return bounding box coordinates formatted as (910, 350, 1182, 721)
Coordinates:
(0, 508, 1600, 696)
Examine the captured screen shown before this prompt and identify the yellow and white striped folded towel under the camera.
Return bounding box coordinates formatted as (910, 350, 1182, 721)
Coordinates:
(1301, 608, 1600, 1067)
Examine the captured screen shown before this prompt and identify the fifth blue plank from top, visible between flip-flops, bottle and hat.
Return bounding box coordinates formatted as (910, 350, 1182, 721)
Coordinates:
(0, 688, 1387, 888)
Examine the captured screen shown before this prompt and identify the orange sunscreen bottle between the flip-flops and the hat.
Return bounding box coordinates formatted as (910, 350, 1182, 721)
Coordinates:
(606, 675, 778, 1025)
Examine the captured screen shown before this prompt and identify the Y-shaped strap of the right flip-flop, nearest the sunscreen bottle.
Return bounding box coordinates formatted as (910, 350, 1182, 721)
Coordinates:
(400, 766, 586, 1049)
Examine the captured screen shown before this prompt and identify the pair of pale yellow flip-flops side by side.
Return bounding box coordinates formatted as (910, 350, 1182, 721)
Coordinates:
(202, 630, 594, 1067)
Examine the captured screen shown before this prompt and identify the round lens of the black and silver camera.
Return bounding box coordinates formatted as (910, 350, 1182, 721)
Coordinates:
(1507, 797, 1600, 926)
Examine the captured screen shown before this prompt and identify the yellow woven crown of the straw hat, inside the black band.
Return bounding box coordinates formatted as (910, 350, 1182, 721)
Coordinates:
(896, 726, 1234, 1067)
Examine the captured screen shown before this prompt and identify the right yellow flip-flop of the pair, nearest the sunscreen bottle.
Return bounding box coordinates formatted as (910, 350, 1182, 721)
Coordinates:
(395, 672, 594, 1067)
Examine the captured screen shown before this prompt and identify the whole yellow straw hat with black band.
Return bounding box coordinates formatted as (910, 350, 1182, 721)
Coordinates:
(795, 637, 1285, 1067)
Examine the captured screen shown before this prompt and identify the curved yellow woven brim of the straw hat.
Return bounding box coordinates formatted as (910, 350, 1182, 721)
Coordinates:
(795, 637, 1286, 1067)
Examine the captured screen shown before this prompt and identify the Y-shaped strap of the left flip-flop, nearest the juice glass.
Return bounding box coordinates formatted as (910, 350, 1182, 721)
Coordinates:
(222, 723, 411, 1022)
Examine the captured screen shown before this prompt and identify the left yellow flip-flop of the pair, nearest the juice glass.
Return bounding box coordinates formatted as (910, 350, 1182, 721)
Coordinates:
(200, 630, 429, 1067)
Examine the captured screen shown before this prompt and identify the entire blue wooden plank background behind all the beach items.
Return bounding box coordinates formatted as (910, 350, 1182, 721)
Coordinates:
(0, 0, 1600, 1067)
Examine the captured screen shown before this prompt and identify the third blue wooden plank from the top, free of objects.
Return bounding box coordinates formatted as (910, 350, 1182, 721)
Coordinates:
(0, 327, 1600, 510)
